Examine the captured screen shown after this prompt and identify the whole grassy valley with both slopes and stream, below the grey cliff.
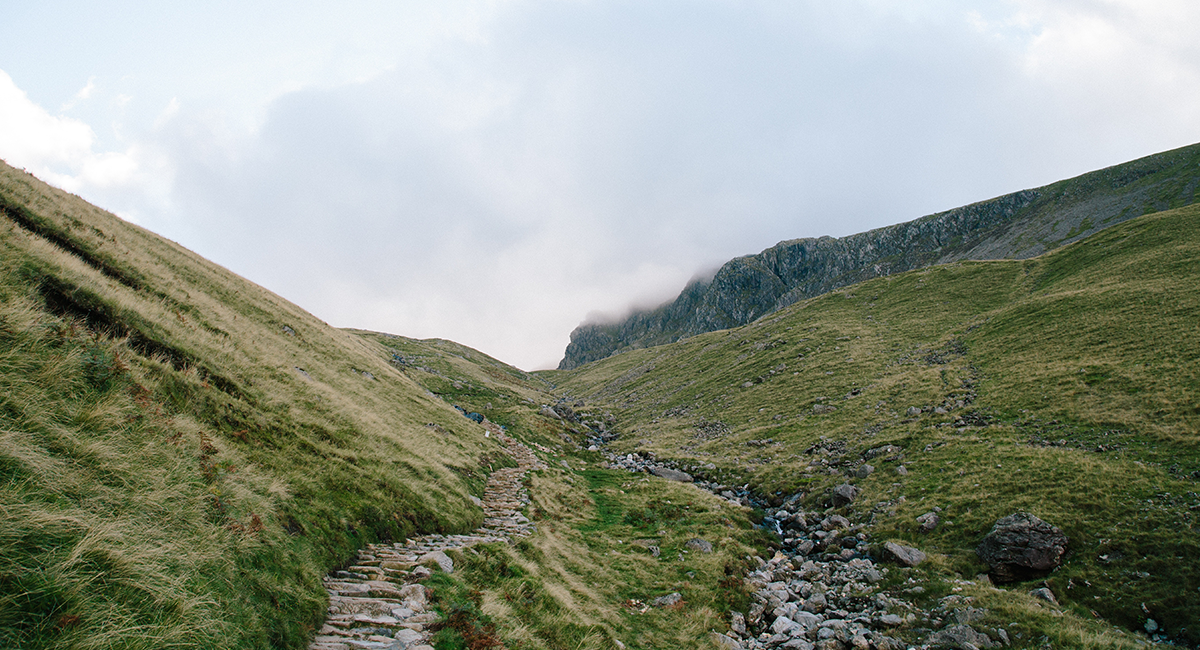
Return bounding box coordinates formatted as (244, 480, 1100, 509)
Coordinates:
(0, 154, 1200, 649)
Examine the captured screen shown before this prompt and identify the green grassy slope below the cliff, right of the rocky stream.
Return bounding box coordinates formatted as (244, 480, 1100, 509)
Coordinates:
(552, 206, 1200, 644)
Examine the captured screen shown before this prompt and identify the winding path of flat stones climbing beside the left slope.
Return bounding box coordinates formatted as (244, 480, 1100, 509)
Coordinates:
(308, 420, 545, 650)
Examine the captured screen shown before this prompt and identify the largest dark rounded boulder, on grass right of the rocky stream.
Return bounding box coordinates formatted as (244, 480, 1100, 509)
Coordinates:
(976, 512, 1068, 583)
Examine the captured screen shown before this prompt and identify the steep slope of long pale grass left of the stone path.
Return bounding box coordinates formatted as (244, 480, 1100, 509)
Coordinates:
(0, 160, 502, 649)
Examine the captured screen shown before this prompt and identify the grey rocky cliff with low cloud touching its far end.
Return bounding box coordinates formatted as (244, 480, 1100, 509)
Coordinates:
(558, 144, 1200, 369)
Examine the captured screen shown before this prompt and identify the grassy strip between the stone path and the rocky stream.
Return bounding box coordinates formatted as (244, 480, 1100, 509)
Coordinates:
(356, 332, 769, 649)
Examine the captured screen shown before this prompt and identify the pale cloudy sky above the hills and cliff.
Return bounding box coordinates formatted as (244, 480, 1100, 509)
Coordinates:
(0, 0, 1200, 369)
